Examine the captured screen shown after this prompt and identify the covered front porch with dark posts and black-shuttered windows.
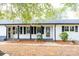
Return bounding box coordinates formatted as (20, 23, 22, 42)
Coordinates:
(6, 24, 55, 40)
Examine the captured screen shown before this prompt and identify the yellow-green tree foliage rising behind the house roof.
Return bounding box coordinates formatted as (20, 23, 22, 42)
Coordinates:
(0, 3, 79, 22)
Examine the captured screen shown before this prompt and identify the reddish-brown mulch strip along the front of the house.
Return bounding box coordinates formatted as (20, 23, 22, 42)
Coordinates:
(5, 40, 74, 45)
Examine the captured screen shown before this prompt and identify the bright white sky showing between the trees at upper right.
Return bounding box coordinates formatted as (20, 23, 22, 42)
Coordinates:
(51, 3, 79, 19)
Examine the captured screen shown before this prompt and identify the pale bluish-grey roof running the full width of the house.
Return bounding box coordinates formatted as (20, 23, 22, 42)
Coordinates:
(0, 19, 79, 25)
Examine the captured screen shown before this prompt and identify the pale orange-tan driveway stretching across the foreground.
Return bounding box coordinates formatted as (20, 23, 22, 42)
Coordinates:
(0, 42, 79, 56)
